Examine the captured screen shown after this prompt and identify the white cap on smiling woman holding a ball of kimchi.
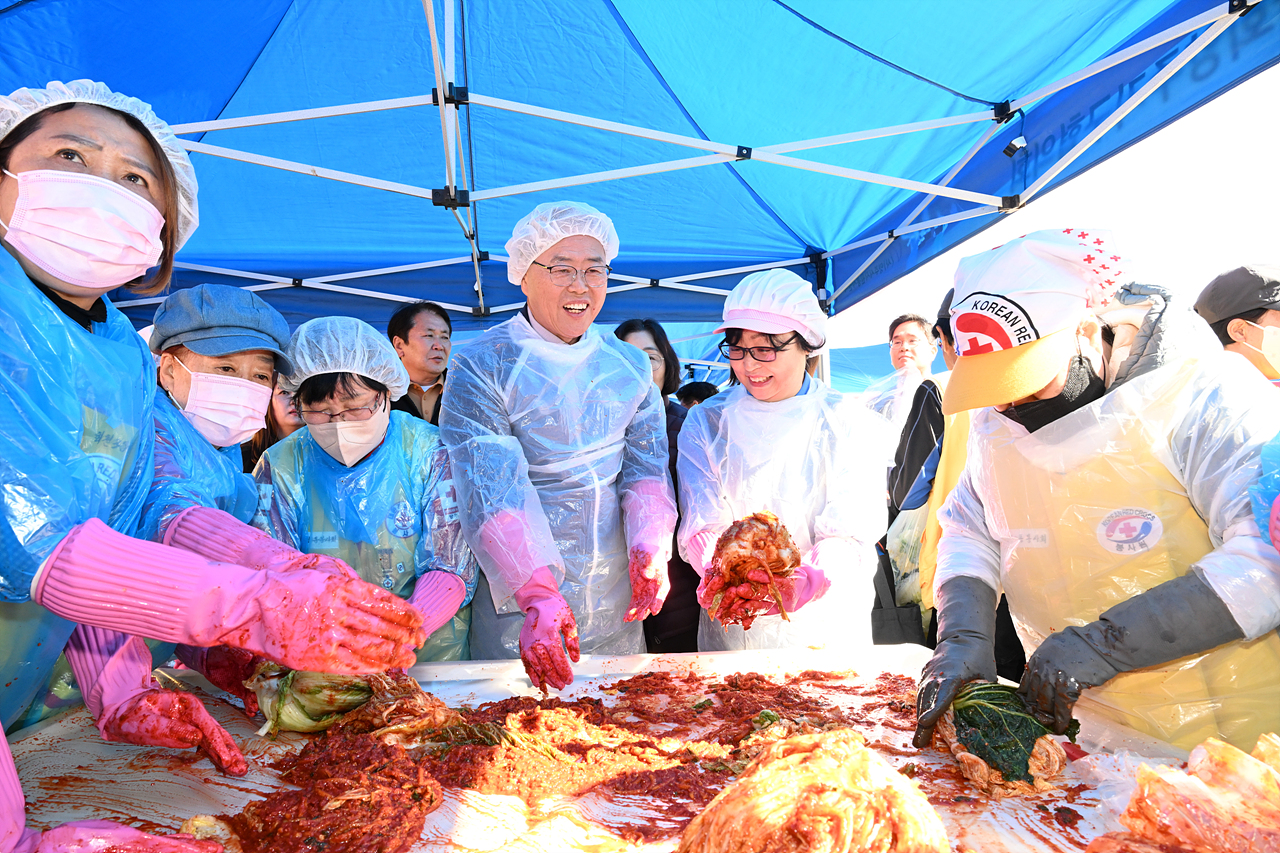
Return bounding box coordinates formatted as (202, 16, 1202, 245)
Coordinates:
(716, 269, 827, 347)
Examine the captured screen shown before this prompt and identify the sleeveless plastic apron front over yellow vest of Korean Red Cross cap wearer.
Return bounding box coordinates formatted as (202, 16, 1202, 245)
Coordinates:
(982, 362, 1280, 751)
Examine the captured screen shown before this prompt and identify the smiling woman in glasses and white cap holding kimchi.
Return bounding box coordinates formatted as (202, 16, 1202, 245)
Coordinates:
(676, 270, 886, 652)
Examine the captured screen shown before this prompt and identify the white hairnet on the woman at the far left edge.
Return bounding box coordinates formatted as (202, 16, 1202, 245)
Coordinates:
(0, 79, 200, 251)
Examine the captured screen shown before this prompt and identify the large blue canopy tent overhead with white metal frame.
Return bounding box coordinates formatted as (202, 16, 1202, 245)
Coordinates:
(0, 0, 1280, 329)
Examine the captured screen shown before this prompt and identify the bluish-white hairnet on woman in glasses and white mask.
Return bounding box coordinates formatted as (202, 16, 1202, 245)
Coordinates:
(280, 316, 408, 400)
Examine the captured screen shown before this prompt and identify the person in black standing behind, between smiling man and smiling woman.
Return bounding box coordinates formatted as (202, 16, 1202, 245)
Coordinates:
(613, 319, 699, 654)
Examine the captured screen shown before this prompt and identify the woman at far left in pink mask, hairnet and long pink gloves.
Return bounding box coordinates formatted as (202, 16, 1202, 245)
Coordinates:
(0, 81, 421, 853)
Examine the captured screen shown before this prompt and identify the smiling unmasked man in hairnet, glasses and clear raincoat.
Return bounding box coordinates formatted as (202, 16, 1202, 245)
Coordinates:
(440, 201, 676, 689)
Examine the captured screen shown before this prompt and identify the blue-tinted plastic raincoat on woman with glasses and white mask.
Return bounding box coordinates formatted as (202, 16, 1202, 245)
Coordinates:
(253, 411, 479, 661)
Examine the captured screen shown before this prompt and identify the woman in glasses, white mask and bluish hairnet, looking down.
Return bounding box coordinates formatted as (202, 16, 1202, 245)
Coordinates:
(253, 316, 477, 661)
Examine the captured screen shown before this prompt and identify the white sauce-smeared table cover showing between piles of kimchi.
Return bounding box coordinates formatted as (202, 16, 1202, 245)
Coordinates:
(10, 646, 1185, 853)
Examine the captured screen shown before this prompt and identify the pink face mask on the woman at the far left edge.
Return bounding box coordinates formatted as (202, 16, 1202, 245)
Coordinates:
(0, 169, 164, 291)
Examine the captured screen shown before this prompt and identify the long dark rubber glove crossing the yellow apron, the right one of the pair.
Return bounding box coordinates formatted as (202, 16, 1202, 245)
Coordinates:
(1018, 563, 1244, 734)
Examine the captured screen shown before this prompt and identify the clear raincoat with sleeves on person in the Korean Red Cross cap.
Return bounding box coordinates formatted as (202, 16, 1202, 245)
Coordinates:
(934, 351, 1280, 749)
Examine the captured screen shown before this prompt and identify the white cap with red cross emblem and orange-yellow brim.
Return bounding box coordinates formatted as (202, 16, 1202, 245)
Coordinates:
(942, 228, 1123, 415)
